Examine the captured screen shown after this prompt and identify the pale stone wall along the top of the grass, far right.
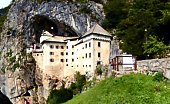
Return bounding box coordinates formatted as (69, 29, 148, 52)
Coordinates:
(137, 58, 170, 79)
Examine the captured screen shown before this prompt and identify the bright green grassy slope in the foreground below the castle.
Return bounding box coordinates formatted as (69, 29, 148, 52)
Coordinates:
(66, 74, 170, 104)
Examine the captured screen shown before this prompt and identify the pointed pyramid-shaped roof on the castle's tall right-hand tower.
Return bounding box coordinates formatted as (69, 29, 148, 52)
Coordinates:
(83, 23, 111, 37)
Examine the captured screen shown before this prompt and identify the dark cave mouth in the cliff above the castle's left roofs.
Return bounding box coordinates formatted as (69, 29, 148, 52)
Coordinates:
(31, 15, 78, 42)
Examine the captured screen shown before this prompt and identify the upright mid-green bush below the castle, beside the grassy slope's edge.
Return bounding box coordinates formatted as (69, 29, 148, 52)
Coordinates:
(70, 72, 86, 95)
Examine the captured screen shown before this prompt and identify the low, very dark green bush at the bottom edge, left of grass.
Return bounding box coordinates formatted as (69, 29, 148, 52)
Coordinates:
(47, 87, 73, 104)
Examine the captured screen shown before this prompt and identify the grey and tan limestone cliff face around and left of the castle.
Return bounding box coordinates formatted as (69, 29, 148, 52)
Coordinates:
(0, 0, 104, 104)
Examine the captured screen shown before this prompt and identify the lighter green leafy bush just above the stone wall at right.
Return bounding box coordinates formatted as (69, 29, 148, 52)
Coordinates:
(144, 36, 168, 58)
